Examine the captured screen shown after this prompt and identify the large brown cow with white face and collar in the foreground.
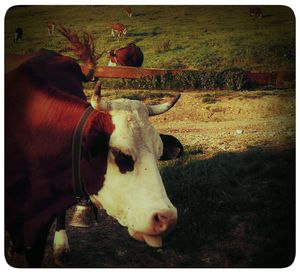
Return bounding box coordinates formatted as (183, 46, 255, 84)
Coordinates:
(5, 29, 182, 266)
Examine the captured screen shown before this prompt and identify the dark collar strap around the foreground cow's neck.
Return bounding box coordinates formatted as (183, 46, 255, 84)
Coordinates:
(72, 106, 94, 199)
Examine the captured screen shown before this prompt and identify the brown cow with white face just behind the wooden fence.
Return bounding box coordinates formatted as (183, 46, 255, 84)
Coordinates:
(108, 43, 144, 67)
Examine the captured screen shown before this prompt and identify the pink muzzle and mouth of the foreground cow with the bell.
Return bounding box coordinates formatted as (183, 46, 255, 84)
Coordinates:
(128, 209, 177, 248)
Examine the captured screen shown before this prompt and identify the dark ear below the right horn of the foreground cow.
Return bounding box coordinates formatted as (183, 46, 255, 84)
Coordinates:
(159, 134, 183, 161)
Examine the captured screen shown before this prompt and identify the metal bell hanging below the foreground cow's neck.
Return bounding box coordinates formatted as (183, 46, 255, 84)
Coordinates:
(70, 199, 97, 227)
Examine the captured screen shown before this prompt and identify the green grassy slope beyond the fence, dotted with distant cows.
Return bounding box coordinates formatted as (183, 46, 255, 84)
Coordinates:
(5, 6, 295, 71)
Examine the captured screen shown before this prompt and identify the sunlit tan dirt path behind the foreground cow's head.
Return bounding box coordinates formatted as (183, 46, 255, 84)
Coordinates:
(151, 91, 295, 154)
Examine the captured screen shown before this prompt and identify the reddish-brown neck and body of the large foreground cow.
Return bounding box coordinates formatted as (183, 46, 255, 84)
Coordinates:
(5, 49, 113, 265)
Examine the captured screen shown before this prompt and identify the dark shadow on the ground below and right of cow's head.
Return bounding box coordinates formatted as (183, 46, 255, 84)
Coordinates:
(14, 148, 295, 267)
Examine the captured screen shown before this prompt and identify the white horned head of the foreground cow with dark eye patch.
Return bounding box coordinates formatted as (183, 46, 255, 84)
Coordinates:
(90, 82, 182, 247)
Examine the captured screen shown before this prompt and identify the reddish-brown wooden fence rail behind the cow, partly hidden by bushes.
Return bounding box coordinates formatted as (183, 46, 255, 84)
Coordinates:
(81, 66, 295, 88)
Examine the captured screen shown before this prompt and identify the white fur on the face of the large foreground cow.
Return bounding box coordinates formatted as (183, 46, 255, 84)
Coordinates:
(92, 99, 177, 234)
